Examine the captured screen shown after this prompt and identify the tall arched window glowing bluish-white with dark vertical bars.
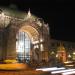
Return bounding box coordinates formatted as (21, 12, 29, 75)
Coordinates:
(16, 32, 31, 61)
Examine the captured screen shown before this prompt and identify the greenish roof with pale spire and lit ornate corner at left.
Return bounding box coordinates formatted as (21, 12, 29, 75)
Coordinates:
(0, 7, 38, 27)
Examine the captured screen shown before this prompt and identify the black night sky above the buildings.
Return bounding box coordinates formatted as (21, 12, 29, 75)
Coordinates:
(0, 0, 75, 42)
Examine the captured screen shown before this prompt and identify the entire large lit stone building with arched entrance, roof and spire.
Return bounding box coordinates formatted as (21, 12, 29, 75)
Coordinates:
(0, 9, 50, 62)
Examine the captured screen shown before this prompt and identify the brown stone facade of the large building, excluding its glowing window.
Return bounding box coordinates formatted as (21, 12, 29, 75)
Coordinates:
(0, 7, 50, 61)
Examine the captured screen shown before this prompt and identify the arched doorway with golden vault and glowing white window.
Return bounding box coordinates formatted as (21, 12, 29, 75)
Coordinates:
(16, 25, 39, 63)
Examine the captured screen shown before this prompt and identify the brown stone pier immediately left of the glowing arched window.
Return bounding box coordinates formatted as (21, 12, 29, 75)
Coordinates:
(6, 26, 16, 59)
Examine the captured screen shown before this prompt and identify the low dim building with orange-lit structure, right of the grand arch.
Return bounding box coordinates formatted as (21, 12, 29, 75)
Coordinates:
(50, 39, 75, 62)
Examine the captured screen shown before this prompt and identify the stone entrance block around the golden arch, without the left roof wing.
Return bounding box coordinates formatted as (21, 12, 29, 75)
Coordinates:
(4, 10, 50, 62)
